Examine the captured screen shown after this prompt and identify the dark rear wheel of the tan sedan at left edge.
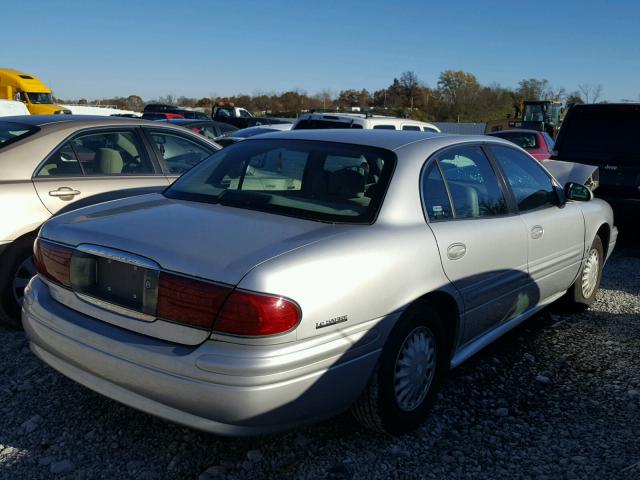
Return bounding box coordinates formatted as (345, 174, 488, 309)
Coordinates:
(0, 237, 35, 329)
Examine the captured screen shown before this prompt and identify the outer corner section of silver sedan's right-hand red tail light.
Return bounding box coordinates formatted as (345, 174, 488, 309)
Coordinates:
(213, 291, 300, 336)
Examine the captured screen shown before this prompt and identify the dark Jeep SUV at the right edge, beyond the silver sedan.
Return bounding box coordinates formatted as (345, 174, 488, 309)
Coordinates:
(551, 103, 640, 215)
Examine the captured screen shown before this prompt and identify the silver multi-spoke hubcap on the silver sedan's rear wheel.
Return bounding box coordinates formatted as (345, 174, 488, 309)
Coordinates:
(394, 327, 436, 412)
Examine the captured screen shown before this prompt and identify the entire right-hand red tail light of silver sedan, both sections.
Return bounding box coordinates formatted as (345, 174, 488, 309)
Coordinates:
(157, 272, 300, 336)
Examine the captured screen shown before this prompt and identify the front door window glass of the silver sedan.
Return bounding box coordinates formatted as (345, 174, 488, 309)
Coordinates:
(491, 145, 558, 211)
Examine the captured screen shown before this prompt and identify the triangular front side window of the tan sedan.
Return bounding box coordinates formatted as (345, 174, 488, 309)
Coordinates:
(145, 128, 217, 182)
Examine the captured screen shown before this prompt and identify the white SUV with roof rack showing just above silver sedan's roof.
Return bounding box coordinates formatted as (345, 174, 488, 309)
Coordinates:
(293, 113, 440, 133)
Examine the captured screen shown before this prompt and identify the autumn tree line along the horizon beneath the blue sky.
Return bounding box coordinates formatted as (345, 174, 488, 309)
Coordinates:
(60, 70, 602, 122)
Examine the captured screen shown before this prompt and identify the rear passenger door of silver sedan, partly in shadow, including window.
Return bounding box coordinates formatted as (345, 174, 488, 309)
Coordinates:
(422, 145, 538, 343)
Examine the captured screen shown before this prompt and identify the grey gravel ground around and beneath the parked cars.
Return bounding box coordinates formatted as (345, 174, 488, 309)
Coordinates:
(0, 249, 640, 480)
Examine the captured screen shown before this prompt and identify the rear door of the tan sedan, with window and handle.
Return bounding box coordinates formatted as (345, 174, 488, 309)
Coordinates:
(32, 127, 168, 213)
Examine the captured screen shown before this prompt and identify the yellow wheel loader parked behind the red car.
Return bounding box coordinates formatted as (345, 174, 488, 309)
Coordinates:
(485, 100, 564, 138)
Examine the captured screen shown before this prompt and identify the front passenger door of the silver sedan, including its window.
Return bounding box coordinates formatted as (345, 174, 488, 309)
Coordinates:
(490, 145, 585, 300)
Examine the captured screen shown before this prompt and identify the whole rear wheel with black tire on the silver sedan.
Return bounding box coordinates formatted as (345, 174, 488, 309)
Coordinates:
(351, 306, 449, 435)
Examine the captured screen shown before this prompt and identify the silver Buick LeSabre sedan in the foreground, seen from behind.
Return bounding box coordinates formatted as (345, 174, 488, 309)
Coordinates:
(23, 130, 617, 435)
